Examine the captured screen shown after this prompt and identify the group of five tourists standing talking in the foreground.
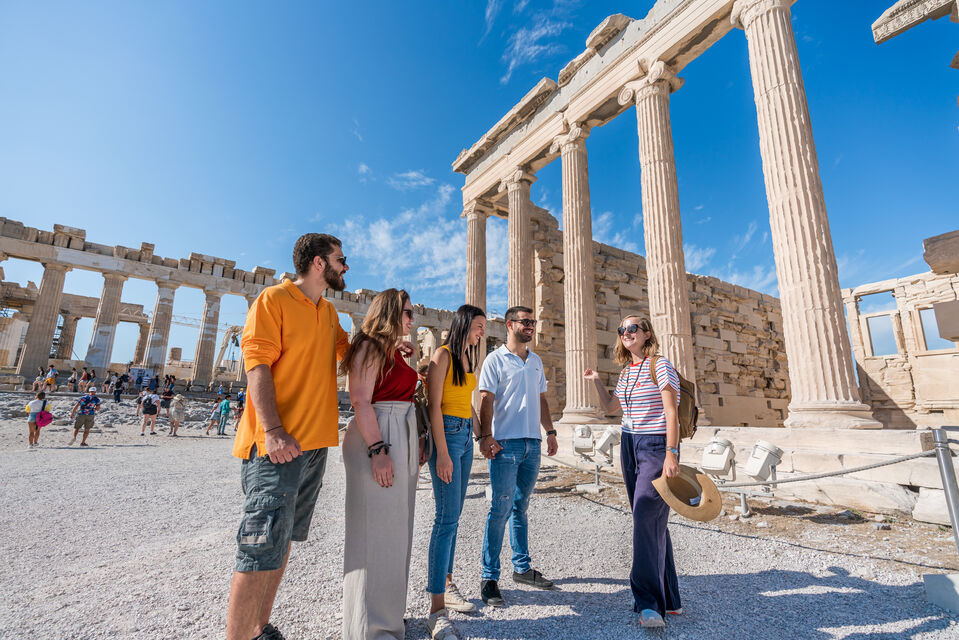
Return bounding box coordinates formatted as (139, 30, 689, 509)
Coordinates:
(227, 233, 682, 640)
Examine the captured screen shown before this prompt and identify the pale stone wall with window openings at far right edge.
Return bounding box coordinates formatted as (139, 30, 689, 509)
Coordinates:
(843, 273, 959, 429)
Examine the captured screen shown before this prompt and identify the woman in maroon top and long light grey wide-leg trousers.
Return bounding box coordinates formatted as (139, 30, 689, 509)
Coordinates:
(341, 289, 422, 640)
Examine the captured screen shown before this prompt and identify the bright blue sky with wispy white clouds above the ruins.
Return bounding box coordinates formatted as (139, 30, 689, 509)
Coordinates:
(0, 0, 959, 361)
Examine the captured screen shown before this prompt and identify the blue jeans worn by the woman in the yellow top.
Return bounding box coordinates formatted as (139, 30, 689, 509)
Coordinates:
(426, 415, 473, 594)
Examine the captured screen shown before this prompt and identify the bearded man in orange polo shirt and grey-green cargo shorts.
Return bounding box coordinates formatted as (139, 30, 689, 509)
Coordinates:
(227, 233, 349, 640)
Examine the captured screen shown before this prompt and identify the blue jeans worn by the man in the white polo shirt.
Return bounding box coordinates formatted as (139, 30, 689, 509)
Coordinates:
(482, 438, 541, 580)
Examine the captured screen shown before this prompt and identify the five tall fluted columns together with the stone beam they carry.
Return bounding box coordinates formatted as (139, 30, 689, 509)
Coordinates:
(453, 0, 881, 428)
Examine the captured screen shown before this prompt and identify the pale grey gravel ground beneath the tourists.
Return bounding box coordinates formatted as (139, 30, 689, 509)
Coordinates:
(0, 394, 959, 640)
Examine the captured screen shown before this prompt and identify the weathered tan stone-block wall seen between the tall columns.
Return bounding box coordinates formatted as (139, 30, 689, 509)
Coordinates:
(533, 208, 789, 427)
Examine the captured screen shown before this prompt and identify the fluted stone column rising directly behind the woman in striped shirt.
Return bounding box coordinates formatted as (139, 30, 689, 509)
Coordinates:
(619, 60, 696, 380)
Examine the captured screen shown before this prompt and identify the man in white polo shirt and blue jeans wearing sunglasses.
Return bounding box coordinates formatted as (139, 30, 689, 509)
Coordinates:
(476, 307, 558, 607)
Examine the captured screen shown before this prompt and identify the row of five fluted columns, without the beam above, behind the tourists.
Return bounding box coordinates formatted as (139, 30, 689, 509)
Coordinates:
(464, 0, 880, 428)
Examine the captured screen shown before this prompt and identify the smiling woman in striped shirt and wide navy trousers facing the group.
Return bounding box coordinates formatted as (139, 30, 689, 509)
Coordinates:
(583, 316, 682, 627)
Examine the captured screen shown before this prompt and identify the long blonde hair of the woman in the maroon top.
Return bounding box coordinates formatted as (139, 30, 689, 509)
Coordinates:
(340, 289, 410, 379)
